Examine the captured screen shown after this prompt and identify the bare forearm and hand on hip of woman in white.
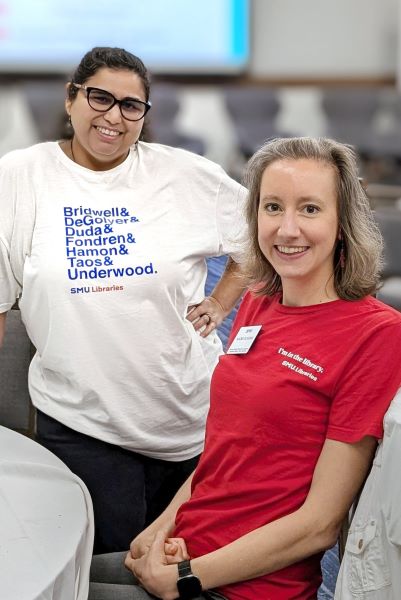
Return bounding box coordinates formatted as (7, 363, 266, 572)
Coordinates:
(187, 258, 245, 337)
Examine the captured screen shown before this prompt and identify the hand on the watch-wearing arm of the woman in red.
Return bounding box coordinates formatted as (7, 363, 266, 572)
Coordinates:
(125, 531, 178, 600)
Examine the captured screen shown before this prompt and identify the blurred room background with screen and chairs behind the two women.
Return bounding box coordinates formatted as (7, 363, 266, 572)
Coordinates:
(0, 0, 401, 600)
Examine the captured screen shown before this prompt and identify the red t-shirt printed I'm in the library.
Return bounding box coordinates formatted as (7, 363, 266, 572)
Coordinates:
(174, 293, 401, 600)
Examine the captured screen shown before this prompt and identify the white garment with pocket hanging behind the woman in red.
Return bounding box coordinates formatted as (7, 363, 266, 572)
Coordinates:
(335, 389, 401, 600)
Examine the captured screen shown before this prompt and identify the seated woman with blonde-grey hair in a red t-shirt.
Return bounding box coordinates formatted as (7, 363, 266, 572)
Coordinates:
(90, 138, 401, 600)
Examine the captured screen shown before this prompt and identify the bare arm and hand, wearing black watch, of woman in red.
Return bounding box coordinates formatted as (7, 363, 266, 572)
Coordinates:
(133, 437, 376, 600)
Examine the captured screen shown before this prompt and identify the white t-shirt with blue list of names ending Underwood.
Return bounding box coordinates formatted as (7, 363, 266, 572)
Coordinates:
(0, 142, 245, 461)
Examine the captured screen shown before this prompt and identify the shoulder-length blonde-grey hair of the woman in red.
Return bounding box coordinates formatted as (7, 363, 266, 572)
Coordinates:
(242, 137, 383, 300)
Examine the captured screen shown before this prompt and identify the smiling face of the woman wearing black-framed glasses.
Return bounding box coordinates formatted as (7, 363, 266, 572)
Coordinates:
(66, 67, 146, 170)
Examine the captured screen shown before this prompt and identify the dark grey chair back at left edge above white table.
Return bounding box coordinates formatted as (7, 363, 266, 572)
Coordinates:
(0, 310, 34, 436)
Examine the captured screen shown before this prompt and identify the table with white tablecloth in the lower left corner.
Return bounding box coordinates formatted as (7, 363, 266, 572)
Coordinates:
(0, 427, 94, 600)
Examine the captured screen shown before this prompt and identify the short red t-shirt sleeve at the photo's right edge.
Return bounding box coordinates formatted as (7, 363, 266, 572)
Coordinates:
(327, 319, 401, 443)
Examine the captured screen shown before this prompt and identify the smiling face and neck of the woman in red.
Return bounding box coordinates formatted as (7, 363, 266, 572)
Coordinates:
(258, 159, 339, 305)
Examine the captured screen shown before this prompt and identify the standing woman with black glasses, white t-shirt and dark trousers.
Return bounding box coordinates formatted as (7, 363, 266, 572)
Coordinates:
(0, 48, 245, 552)
